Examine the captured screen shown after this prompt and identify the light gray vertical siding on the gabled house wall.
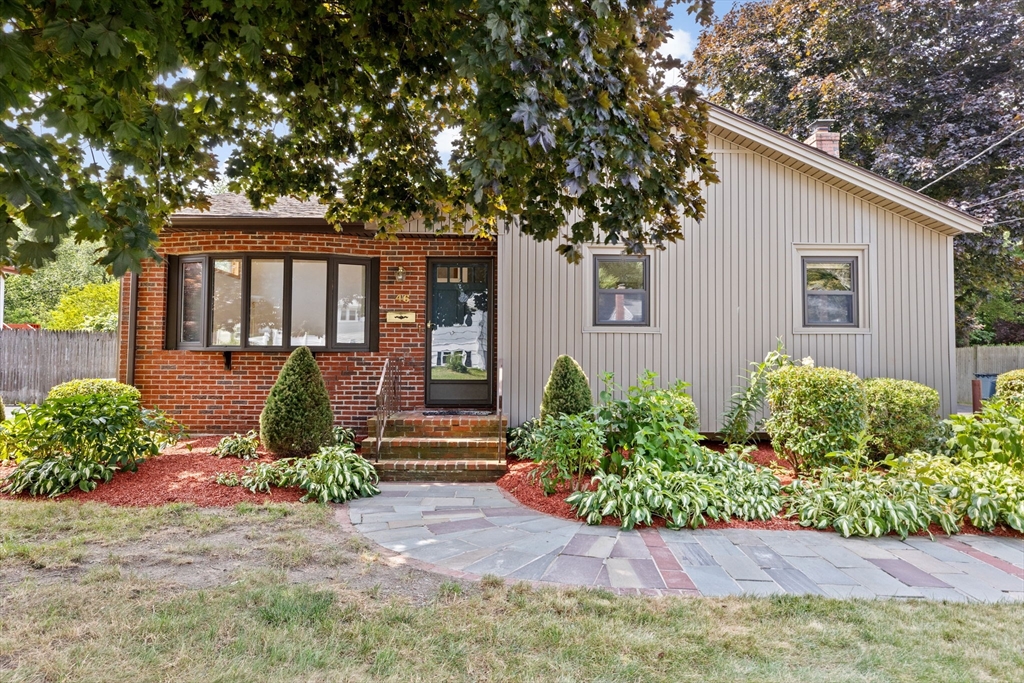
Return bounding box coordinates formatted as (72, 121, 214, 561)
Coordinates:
(498, 136, 955, 431)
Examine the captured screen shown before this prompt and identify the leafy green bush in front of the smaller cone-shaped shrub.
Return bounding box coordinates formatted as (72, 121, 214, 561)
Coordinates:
(522, 413, 604, 496)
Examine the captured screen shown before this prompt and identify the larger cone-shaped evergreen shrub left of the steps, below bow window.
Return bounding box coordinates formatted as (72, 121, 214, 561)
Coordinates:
(259, 346, 334, 456)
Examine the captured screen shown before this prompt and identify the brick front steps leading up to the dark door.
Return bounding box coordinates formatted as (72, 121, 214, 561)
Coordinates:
(362, 411, 508, 481)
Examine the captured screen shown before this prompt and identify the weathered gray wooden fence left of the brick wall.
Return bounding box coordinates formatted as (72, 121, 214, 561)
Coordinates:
(0, 330, 118, 405)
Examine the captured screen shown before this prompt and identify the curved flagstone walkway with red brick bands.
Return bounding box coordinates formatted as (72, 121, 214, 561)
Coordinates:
(339, 483, 1024, 602)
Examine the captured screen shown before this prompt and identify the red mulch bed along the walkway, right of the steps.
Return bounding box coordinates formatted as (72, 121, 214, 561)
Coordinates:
(497, 443, 1024, 539)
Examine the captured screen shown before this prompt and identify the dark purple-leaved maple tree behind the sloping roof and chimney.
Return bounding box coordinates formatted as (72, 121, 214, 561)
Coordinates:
(691, 0, 1024, 343)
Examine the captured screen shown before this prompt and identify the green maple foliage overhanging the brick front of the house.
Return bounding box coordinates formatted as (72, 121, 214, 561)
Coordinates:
(0, 0, 715, 274)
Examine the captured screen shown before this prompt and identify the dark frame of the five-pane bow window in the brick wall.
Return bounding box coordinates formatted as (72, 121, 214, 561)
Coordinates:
(164, 252, 380, 353)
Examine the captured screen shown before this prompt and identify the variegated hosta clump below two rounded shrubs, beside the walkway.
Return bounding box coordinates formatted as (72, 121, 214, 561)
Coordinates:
(783, 468, 946, 538)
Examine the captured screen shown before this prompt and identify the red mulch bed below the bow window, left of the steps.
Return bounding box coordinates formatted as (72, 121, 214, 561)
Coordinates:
(0, 436, 302, 508)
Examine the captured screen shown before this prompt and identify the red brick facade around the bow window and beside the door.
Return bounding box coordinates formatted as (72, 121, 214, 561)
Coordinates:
(118, 227, 497, 434)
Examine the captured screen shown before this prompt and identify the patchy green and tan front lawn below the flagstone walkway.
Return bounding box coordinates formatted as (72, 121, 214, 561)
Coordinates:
(0, 501, 1024, 681)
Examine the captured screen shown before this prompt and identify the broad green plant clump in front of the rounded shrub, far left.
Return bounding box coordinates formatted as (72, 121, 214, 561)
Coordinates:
(0, 394, 183, 496)
